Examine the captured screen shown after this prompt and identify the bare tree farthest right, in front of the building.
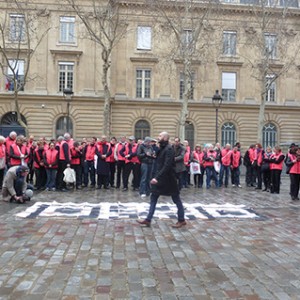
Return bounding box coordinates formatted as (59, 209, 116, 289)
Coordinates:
(245, 0, 300, 143)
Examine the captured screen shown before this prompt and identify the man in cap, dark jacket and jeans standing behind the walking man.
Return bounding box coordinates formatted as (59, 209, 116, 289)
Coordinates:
(137, 136, 156, 198)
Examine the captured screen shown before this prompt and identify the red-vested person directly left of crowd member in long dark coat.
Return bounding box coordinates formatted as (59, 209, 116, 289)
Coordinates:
(82, 137, 97, 188)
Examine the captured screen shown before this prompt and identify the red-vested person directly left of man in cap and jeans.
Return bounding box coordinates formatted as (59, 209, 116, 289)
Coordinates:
(120, 136, 140, 192)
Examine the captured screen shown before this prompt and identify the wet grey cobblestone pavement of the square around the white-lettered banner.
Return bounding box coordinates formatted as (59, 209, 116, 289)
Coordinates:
(0, 178, 300, 300)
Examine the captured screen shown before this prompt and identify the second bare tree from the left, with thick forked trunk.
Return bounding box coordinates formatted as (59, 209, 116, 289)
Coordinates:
(66, 0, 127, 136)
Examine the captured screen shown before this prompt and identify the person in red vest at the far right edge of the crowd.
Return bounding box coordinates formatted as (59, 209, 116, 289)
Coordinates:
(286, 145, 300, 201)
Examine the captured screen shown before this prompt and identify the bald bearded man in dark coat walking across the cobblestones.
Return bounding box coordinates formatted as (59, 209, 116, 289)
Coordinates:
(137, 131, 186, 228)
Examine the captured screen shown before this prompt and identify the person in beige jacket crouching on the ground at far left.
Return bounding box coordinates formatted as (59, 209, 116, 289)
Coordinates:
(2, 166, 33, 203)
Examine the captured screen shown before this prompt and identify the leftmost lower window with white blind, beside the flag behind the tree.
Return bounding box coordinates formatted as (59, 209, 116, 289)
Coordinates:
(5, 60, 25, 91)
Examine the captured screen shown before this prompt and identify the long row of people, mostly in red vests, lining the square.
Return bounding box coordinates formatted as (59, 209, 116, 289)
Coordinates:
(0, 132, 300, 200)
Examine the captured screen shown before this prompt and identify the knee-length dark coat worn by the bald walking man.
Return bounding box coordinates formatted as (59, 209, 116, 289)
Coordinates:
(151, 144, 179, 196)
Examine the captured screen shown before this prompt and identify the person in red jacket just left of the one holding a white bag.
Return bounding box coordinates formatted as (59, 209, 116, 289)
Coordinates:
(44, 142, 58, 191)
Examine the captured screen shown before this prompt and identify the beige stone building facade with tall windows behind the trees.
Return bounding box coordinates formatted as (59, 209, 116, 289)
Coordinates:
(0, 0, 300, 148)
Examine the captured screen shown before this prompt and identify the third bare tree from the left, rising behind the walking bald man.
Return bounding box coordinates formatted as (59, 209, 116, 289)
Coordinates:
(147, 0, 218, 140)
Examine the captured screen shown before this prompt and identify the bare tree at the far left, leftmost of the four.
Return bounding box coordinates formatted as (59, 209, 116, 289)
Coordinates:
(0, 0, 49, 135)
